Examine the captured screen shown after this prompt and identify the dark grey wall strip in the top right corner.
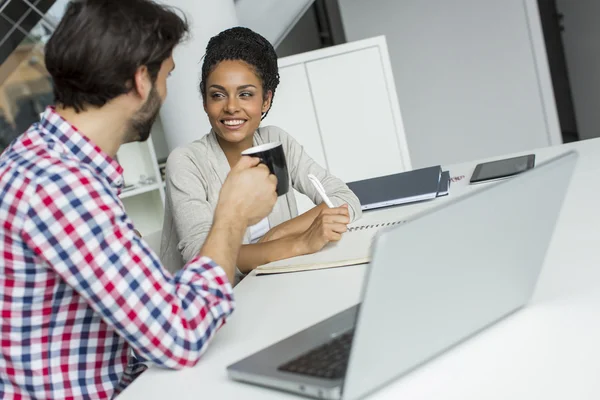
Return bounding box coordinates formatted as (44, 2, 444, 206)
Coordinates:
(556, 0, 600, 139)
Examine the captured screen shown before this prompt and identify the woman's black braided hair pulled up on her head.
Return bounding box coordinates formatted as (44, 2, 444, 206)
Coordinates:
(200, 27, 279, 119)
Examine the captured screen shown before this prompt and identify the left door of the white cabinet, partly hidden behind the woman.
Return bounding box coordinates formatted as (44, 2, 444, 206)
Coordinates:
(262, 64, 327, 213)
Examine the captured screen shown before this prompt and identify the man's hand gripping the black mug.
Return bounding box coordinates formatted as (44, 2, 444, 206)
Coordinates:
(215, 156, 277, 226)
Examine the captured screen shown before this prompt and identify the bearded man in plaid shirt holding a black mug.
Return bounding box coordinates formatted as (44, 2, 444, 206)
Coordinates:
(0, 0, 276, 399)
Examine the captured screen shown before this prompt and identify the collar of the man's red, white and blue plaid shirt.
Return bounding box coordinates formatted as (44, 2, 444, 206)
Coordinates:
(40, 106, 123, 191)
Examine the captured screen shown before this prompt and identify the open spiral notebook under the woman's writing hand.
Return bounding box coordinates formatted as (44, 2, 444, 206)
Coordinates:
(255, 221, 406, 275)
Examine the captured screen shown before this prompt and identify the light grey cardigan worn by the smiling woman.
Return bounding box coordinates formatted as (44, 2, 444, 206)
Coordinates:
(160, 126, 362, 272)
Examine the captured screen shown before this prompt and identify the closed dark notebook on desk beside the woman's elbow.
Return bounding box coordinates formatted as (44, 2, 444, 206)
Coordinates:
(348, 165, 442, 210)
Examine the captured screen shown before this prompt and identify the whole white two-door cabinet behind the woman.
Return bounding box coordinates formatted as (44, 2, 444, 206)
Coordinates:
(263, 36, 411, 212)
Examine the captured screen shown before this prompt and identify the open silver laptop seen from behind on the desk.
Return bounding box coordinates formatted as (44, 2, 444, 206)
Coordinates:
(227, 152, 578, 400)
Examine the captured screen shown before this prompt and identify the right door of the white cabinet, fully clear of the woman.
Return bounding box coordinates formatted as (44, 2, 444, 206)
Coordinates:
(306, 46, 403, 182)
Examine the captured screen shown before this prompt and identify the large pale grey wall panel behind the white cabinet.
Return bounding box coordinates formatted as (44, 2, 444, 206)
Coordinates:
(340, 0, 561, 167)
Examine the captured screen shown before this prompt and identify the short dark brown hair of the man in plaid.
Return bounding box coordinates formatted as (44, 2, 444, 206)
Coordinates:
(45, 0, 189, 112)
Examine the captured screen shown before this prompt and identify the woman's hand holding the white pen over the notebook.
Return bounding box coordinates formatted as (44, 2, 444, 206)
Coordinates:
(300, 205, 350, 254)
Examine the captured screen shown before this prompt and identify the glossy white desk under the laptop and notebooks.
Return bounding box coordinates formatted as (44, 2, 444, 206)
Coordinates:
(119, 139, 600, 400)
